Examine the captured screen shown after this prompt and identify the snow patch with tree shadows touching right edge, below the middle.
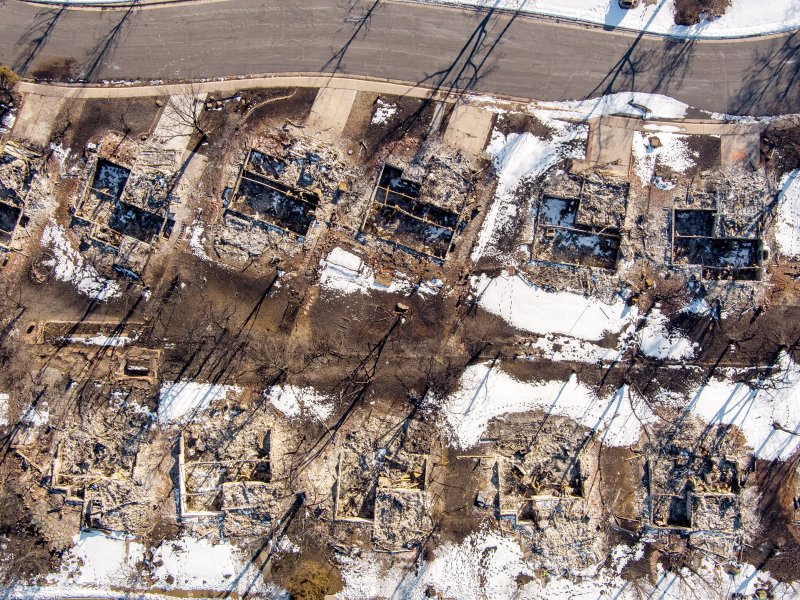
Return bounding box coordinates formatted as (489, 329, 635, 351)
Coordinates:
(662, 353, 800, 460)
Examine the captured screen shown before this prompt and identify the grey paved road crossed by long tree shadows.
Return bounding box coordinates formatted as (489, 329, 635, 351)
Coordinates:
(0, 0, 800, 114)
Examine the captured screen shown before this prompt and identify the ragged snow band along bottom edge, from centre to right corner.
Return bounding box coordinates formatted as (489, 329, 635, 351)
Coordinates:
(338, 530, 800, 600)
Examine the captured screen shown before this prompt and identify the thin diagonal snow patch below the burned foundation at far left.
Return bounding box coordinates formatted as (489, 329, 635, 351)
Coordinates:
(42, 223, 121, 302)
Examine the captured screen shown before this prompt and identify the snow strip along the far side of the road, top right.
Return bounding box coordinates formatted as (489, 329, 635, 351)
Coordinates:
(410, 0, 800, 39)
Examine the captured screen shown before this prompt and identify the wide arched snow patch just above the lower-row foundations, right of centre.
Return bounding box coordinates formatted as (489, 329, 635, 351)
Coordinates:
(443, 363, 655, 449)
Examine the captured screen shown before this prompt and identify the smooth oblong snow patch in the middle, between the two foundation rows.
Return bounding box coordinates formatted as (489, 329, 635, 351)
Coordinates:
(471, 273, 638, 341)
